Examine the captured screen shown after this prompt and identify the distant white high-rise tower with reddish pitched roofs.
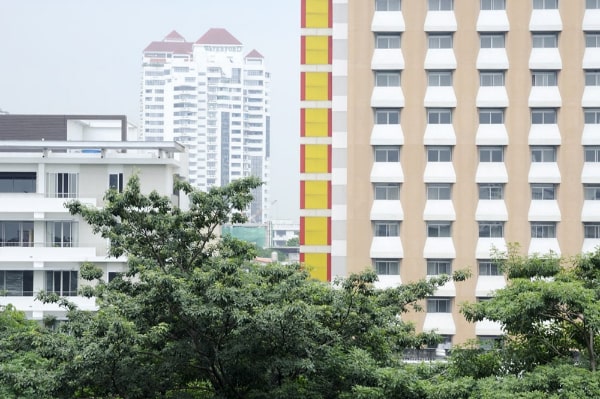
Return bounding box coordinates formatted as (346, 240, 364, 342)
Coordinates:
(141, 29, 270, 223)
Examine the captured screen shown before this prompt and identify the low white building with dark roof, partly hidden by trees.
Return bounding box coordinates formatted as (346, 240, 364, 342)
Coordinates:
(0, 115, 187, 320)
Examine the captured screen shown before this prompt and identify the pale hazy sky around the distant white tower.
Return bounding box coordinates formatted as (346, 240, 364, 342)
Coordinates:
(0, 0, 300, 219)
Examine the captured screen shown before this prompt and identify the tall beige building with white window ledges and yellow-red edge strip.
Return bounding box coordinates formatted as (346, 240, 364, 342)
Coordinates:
(300, 0, 600, 345)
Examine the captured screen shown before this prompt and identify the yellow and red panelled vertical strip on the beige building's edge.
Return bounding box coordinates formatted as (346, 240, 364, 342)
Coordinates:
(300, 0, 333, 281)
